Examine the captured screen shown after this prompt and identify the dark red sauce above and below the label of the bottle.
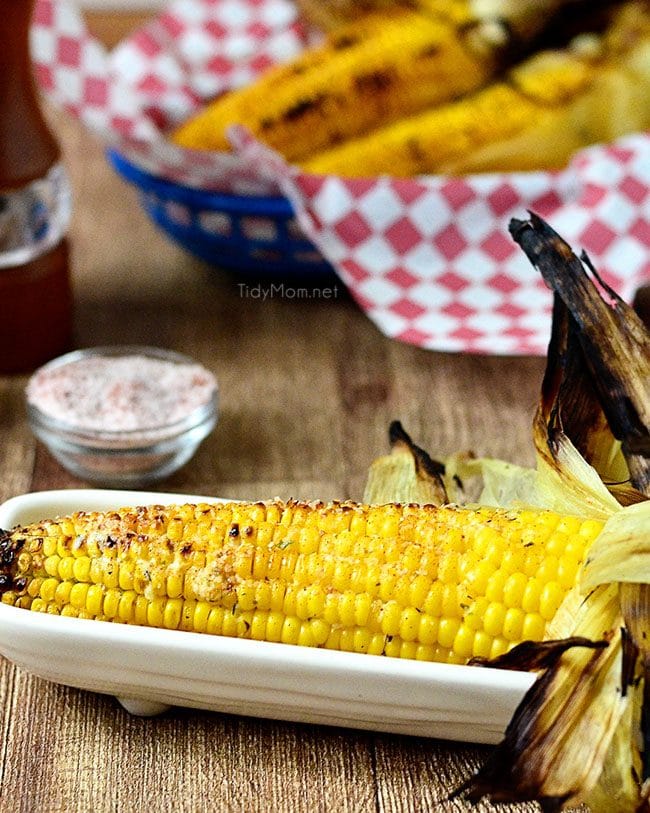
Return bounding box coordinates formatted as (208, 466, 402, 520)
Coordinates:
(0, 0, 72, 373)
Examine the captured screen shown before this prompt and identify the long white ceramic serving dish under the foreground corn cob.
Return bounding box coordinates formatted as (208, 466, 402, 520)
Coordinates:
(0, 490, 534, 743)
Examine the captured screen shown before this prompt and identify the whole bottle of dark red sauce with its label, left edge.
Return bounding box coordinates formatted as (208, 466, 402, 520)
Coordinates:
(0, 0, 72, 374)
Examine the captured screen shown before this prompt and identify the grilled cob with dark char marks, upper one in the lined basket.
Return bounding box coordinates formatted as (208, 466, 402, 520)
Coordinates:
(173, 3, 507, 161)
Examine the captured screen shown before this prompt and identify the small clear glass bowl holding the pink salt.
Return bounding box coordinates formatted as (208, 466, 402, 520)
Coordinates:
(26, 346, 218, 488)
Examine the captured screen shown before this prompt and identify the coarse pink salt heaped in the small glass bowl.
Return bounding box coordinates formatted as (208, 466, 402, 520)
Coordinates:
(27, 354, 217, 432)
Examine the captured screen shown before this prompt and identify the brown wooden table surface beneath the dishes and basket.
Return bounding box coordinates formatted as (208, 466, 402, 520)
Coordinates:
(0, 14, 588, 813)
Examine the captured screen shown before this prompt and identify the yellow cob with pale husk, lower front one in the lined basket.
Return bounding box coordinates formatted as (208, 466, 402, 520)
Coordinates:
(302, 3, 650, 177)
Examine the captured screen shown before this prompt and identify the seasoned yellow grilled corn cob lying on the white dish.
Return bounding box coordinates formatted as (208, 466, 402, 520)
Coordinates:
(0, 502, 602, 663)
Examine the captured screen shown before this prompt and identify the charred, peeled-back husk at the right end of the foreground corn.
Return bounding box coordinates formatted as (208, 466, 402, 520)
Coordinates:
(454, 215, 650, 813)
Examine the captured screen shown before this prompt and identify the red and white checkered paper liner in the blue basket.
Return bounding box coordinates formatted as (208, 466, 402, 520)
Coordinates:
(32, 0, 650, 355)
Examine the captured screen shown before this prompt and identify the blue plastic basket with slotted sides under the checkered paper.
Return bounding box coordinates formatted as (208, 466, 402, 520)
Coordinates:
(107, 150, 334, 276)
